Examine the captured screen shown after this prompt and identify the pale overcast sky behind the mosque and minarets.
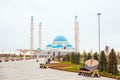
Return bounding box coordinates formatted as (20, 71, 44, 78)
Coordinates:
(0, 0, 120, 51)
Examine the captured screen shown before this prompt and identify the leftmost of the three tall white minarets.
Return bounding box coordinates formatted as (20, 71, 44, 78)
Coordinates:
(30, 16, 34, 50)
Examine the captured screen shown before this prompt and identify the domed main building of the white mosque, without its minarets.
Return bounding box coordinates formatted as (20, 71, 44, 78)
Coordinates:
(46, 35, 74, 56)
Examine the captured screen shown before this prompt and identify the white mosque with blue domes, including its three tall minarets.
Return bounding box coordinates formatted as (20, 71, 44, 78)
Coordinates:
(30, 16, 79, 56)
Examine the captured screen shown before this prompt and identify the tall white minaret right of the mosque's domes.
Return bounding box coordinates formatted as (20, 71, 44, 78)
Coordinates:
(75, 16, 79, 53)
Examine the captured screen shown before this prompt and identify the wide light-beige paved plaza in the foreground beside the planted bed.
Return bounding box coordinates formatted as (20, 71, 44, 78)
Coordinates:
(0, 59, 113, 80)
